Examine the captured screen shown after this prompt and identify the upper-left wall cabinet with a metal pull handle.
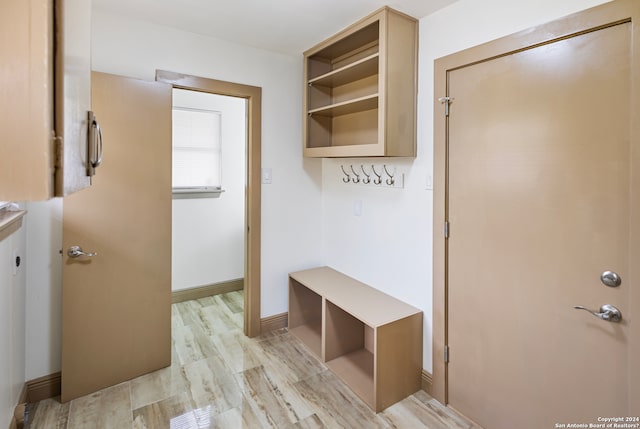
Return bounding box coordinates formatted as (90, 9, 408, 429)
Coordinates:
(0, 0, 97, 201)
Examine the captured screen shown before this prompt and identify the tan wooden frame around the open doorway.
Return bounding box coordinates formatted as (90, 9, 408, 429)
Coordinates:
(156, 70, 262, 337)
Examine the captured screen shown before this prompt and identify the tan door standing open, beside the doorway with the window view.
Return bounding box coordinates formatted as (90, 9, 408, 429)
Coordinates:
(62, 73, 171, 401)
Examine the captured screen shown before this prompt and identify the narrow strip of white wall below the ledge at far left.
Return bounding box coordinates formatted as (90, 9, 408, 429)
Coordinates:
(0, 214, 27, 427)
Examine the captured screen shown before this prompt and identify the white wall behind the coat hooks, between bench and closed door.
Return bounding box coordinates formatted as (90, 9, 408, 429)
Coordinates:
(322, 0, 606, 371)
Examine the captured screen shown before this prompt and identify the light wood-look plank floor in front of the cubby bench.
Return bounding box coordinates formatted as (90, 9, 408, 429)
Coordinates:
(27, 291, 474, 429)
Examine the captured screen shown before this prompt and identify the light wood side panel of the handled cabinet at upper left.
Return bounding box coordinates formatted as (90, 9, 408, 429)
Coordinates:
(0, 0, 53, 201)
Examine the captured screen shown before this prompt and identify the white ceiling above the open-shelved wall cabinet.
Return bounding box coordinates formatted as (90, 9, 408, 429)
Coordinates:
(93, 0, 456, 54)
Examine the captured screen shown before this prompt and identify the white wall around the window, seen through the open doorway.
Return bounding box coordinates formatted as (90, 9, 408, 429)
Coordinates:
(171, 91, 247, 291)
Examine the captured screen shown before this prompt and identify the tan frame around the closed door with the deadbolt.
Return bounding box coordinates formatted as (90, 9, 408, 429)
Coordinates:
(430, 0, 640, 410)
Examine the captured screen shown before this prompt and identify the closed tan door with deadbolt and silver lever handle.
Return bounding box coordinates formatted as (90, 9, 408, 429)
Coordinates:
(447, 19, 640, 429)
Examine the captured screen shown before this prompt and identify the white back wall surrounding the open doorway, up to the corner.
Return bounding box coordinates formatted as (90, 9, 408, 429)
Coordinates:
(92, 12, 321, 310)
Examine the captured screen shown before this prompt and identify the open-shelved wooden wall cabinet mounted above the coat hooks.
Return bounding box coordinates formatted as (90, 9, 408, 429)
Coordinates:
(304, 7, 418, 157)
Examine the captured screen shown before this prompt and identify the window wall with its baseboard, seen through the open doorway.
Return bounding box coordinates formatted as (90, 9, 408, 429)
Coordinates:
(171, 88, 247, 303)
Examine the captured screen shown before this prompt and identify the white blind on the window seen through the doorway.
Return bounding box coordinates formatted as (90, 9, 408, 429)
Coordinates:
(172, 107, 222, 191)
